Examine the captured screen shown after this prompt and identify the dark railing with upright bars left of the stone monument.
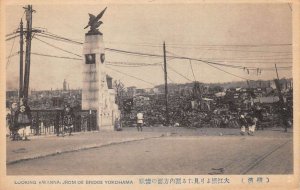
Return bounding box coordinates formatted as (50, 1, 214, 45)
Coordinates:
(30, 109, 98, 135)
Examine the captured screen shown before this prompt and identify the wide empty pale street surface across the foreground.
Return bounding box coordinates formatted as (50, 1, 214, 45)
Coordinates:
(7, 127, 293, 175)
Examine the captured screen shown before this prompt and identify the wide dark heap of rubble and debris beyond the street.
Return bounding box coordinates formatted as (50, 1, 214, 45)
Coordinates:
(121, 86, 292, 128)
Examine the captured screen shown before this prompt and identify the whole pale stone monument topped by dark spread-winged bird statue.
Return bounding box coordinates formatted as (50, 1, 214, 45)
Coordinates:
(82, 8, 120, 130)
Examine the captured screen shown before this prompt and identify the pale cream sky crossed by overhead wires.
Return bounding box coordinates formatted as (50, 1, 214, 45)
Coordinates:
(6, 3, 292, 90)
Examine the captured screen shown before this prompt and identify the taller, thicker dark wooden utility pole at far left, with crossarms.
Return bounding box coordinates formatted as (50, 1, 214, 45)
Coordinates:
(23, 5, 34, 99)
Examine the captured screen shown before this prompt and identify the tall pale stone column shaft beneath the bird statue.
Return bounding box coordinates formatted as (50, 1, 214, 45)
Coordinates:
(82, 34, 106, 129)
